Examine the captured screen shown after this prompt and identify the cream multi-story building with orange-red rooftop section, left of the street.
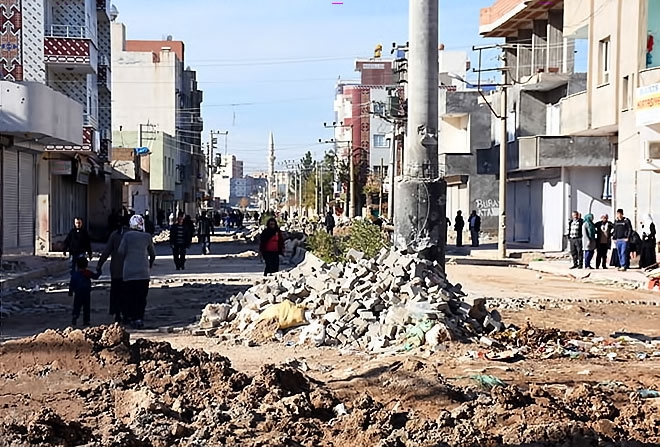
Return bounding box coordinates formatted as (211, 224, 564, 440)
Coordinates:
(112, 22, 206, 219)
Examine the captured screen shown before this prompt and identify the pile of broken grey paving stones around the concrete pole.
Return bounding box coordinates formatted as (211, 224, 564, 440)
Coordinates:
(200, 249, 504, 351)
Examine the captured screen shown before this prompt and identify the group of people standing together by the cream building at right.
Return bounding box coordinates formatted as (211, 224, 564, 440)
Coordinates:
(567, 209, 657, 271)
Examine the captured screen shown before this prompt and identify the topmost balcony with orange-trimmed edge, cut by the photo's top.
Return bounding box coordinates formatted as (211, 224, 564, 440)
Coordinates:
(479, 0, 562, 37)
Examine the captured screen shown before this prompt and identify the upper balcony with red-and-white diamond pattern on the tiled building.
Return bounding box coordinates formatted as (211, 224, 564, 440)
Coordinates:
(44, 25, 98, 74)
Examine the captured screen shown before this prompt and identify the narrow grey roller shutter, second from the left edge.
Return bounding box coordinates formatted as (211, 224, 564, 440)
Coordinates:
(18, 152, 36, 253)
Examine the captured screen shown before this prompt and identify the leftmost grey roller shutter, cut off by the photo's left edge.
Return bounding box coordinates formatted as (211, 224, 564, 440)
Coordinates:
(2, 150, 19, 253)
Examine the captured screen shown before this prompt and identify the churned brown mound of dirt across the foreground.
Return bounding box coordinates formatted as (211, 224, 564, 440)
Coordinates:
(0, 325, 660, 447)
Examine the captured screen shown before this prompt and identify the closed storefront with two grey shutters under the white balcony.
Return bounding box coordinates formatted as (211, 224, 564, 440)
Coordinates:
(2, 148, 36, 254)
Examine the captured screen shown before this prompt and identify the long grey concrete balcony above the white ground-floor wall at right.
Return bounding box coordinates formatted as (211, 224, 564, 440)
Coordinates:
(512, 136, 612, 170)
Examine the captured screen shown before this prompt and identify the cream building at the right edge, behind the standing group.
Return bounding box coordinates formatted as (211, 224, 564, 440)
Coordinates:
(560, 0, 660, 234)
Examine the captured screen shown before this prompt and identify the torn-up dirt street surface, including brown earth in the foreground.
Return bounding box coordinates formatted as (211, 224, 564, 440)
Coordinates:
(0, 243, 660, 447)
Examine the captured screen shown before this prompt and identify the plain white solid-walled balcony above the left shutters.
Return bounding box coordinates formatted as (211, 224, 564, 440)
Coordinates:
(0, 80, 83, 145)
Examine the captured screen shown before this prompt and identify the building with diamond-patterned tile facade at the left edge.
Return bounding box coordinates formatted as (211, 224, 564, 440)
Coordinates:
(0, 0, 112, 252)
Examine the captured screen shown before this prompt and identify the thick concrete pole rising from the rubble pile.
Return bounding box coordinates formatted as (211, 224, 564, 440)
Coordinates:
(394, 0, 447, 267)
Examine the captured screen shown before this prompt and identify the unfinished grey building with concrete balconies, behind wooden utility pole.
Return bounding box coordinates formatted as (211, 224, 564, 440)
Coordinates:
(480, 0, 612, 250)
